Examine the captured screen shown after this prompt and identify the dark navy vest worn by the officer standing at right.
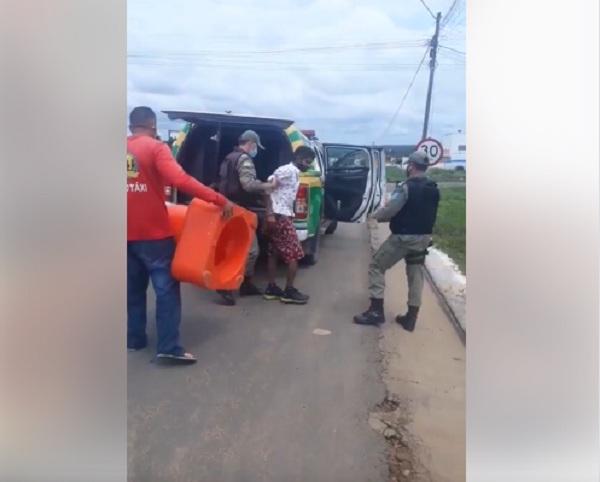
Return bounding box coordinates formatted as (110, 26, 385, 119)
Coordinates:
(390, 177, 440, 234)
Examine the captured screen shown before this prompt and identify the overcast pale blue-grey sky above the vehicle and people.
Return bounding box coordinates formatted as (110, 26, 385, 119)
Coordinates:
(127, 0, 465, 144)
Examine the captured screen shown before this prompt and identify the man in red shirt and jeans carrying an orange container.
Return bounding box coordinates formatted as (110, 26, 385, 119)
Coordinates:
(127, 107, 233, 363)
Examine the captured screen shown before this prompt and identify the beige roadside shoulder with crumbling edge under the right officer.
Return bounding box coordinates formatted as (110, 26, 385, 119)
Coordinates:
(370, 225, 466, 482)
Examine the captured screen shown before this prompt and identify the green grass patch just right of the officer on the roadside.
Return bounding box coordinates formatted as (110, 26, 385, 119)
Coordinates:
(433, 186, 467, 273)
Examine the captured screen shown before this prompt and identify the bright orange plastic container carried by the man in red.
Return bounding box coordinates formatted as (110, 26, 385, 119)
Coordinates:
(167, 199, 257, 290)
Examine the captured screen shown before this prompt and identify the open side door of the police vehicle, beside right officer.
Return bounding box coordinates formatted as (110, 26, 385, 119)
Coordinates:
(323, 144, 385, 222)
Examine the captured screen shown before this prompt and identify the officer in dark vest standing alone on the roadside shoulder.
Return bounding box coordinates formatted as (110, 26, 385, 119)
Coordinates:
(354, 151, 440, 331)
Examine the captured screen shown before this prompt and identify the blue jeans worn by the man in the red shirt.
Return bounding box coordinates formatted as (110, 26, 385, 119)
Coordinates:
(127, 238, 184, 355)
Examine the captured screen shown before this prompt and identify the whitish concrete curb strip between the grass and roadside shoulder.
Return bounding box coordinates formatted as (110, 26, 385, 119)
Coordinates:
(425, 248, 467, 335)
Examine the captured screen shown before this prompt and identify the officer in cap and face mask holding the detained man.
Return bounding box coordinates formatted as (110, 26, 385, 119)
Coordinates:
(218, 130, 275, 305)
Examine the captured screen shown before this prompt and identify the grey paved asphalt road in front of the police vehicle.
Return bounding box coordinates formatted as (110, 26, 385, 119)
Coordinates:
(128, 225, 388, 482)
